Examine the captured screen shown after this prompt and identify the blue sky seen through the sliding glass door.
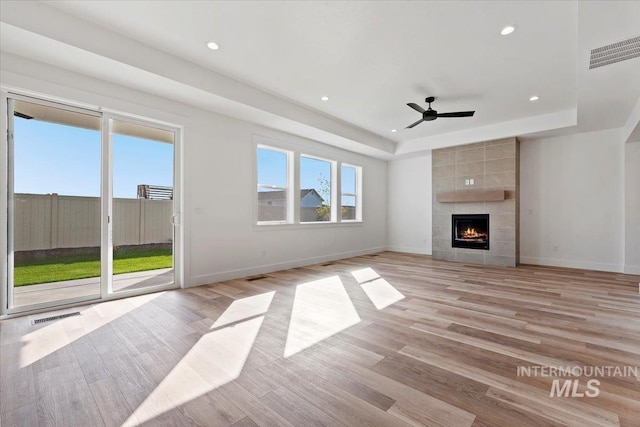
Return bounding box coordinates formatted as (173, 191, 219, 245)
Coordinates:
(14, 117, 173, 198)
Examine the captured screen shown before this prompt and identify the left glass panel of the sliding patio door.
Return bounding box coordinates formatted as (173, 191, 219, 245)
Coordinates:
(8, 100, 101, 308)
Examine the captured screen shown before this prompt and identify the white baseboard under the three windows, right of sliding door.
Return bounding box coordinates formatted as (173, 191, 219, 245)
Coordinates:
(185, 246, 387, 288)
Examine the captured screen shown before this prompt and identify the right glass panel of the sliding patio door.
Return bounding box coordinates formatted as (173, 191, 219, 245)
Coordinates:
(110, 120, 175, 293)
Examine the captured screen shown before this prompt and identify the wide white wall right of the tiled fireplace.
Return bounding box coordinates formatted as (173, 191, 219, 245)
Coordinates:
(520, 129, 624, 271)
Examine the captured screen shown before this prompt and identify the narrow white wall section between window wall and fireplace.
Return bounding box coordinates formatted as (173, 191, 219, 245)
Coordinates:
(387, 154, 432, 255)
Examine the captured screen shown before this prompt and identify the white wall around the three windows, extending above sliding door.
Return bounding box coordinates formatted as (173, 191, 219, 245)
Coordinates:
(0, 54, 384, 285)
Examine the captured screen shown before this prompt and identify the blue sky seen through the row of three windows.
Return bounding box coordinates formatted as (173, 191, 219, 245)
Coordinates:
(258, 148, 356, 206)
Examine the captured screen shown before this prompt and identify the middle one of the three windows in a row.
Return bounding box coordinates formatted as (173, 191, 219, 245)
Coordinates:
(300, 156, 332, 222)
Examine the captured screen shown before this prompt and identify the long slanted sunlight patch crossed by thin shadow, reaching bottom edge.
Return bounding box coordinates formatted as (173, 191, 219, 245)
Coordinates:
(124, 291, 275, 426)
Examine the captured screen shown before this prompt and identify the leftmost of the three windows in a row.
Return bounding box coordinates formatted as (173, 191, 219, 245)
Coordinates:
(257, 146, 290, 223)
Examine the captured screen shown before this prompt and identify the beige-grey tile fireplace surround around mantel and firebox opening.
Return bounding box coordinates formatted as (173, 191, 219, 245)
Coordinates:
(432, 138, 520, 267)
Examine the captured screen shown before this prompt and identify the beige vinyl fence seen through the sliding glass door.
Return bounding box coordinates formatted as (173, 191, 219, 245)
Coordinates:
(14, 194, 173, 251)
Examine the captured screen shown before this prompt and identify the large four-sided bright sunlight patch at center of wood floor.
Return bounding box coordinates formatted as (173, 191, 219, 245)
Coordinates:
(284, 276, 360, 357)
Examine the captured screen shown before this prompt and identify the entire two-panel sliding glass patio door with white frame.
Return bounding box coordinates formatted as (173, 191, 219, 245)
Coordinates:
(0, 95, 179, 313)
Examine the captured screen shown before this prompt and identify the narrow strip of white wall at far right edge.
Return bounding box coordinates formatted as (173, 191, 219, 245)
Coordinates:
(624, 141, 640, 274)
